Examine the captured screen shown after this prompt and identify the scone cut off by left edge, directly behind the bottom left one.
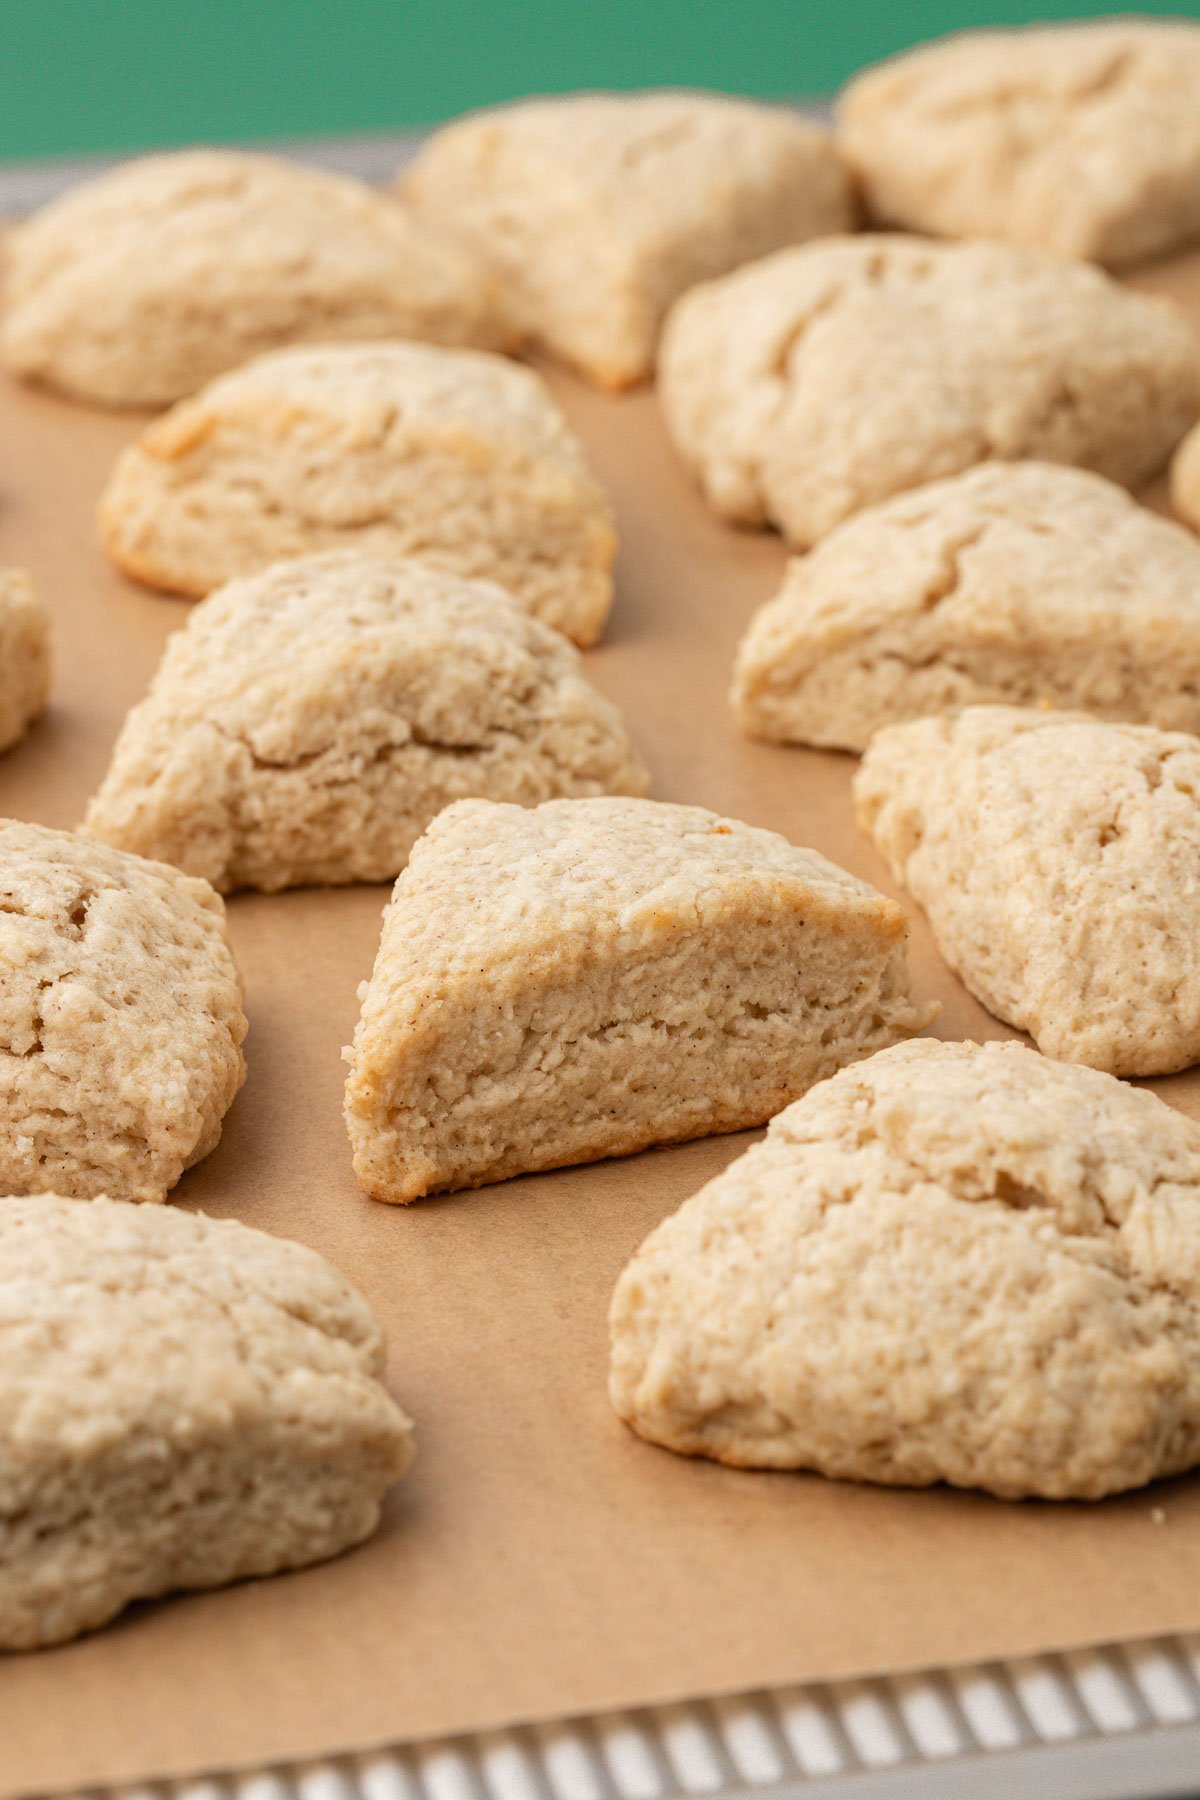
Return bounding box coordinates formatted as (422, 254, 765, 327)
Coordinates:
(0, 819, 246, 1201)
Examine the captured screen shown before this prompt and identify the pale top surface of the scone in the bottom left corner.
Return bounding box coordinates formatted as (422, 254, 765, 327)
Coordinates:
(0, 1193, 407, 1461)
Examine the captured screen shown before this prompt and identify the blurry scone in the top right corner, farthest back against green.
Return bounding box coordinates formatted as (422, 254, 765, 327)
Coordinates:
(838, 20, 1200, 266)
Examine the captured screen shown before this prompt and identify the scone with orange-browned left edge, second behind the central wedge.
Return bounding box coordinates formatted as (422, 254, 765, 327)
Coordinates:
(99, 344, 617, 644)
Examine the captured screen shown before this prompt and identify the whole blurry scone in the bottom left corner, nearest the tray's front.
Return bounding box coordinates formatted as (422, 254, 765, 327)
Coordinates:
(0, 1193, 412, 1651)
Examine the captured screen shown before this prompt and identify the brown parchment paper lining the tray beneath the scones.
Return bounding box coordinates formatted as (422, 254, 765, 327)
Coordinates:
(0, 246, 1200, 1796)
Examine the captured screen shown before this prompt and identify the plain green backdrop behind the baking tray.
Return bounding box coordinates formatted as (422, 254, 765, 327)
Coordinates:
(0, 0, 1200, 160)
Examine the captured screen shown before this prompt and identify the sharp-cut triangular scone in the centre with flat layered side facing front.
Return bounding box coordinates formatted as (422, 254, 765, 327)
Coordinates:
(345, 799, 936, 1201)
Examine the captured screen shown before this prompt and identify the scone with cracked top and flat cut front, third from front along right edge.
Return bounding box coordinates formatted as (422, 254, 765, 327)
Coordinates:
(732, 463, 1200, 751)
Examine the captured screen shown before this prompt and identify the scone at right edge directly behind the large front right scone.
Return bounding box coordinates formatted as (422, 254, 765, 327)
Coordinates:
(855, 706, 1200, 1075)
